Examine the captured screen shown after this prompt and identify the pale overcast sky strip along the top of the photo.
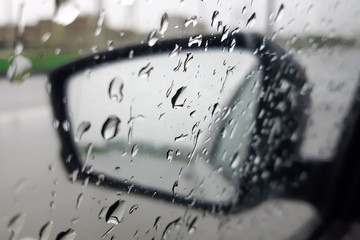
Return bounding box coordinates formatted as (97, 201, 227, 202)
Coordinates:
(0, 0, 360, 37)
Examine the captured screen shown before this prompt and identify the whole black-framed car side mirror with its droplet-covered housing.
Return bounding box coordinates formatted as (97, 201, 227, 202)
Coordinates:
(51, 34, 310, 212)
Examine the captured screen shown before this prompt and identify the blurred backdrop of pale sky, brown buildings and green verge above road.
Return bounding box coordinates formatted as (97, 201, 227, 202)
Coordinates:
(0, 0, 360, 74)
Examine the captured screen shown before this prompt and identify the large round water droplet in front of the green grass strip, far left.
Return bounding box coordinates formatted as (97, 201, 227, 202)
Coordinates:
(6, 55, 32, 83)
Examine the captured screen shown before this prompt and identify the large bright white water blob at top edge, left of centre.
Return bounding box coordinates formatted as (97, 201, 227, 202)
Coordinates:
(53, 1, 80, 26)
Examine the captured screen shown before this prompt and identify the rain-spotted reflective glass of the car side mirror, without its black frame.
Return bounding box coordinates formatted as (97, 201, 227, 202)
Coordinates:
(63, 49, 263, 203)
